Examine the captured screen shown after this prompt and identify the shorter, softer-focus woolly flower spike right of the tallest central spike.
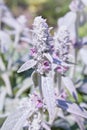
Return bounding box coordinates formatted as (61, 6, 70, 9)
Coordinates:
(53, 26, 72, 73)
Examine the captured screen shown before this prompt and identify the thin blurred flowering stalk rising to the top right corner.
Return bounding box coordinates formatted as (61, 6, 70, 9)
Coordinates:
(70, 0, 85, 80)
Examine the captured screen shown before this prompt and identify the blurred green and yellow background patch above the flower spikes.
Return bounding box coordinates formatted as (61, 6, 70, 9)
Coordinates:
(5, 0, 70, 26)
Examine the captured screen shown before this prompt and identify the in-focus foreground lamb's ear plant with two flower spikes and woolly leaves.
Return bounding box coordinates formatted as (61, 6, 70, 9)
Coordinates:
(1, 12, 87, 130)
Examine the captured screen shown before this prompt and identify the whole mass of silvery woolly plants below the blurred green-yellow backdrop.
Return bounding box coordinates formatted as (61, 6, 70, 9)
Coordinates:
(0, 0, 87, 130)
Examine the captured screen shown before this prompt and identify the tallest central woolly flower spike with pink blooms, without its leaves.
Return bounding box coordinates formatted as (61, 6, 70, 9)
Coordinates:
(31, 16, 52, 74)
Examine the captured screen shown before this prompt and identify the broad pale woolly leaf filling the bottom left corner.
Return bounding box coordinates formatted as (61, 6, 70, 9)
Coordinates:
(1, 108, 30, 130)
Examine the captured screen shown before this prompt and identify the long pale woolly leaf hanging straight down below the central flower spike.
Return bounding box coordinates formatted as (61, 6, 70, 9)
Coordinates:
(42, 76, 56, 123)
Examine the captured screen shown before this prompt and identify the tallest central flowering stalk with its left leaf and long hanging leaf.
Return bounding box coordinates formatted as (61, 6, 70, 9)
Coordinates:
(18, 16, 55, 125)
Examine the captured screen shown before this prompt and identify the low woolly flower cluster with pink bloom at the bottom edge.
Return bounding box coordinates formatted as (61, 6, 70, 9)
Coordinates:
(20, 93, 43, 130)
